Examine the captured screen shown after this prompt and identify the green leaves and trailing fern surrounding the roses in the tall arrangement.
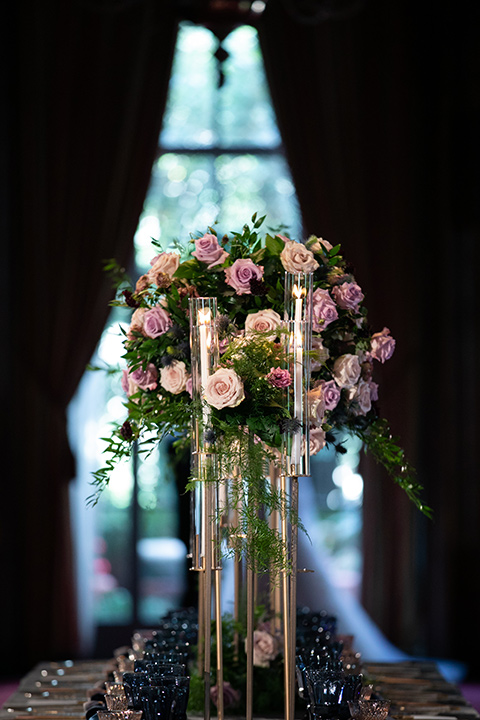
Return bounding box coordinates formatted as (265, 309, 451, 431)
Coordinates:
(89, 215, 431, 572)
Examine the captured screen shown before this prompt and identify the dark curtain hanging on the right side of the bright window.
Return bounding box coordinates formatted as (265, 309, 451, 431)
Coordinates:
(260, 0, 480, 675)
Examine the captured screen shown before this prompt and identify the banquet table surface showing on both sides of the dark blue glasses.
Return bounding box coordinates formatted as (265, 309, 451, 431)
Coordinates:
(0, 660, 480, 720)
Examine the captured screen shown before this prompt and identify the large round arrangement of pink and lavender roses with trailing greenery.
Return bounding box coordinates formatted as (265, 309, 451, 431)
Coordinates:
(91, 215, 430, 570)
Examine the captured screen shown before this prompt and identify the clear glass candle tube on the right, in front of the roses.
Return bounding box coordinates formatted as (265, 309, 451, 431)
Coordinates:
(284, 272, 312, 477)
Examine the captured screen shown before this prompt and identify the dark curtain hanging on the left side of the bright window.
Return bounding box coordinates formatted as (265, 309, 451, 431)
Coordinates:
(0, 0, 176, 672)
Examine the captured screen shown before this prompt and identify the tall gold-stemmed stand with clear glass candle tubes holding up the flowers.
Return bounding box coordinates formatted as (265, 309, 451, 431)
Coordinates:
(189, 272, 312, 720)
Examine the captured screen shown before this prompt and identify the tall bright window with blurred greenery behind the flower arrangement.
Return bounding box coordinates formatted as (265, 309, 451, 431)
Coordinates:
(70, 23, 360, 653)
